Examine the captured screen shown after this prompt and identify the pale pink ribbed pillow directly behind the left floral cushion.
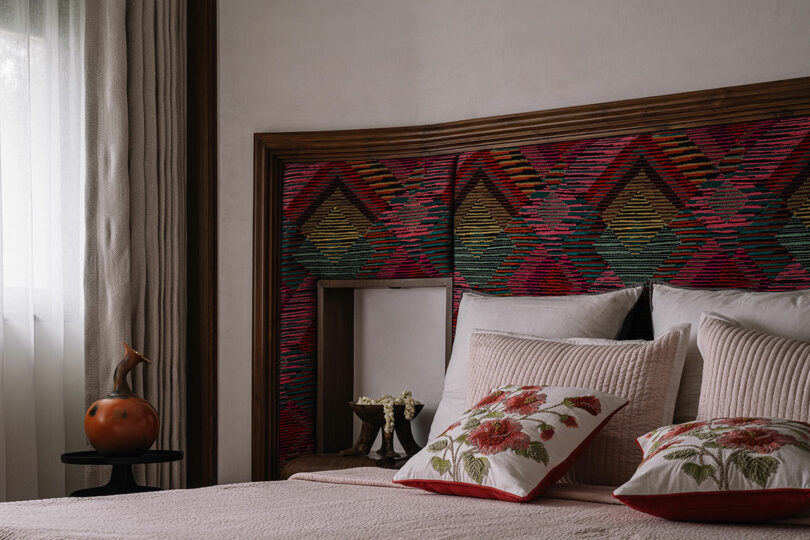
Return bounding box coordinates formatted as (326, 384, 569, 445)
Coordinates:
(467, 325, 689, 486)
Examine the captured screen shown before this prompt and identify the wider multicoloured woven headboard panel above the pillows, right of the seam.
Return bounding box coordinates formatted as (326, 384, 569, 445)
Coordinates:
(454, 118, 810, 299)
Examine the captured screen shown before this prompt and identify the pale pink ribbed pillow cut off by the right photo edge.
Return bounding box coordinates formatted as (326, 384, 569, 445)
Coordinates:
(698, 313, 810, 422)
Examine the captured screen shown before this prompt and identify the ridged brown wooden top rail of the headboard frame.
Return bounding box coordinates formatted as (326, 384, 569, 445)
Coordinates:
(256, 77, 810, 162)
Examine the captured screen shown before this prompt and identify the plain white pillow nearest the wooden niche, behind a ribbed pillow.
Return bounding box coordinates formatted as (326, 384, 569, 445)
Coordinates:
(428, 287, 642, 439)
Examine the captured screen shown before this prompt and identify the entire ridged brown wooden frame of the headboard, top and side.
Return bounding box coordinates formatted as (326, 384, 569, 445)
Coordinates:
(251, 77, 810, 480)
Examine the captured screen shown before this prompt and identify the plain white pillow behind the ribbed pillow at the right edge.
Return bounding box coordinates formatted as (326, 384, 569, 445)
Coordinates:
(651, 283, 810, 423)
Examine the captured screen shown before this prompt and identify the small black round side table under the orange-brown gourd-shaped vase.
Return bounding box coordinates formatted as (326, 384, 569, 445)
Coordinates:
(62, 450, 183, 497)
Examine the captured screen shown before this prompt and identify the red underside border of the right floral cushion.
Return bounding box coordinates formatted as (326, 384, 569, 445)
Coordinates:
(613, 489, 810, 523)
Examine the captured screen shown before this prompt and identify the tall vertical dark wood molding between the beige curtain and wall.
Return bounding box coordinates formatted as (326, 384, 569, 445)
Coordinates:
(186, 0, 218, 487)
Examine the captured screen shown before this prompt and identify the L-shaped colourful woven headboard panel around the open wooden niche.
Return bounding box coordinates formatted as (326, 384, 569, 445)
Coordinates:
(280, 156, 455, 463)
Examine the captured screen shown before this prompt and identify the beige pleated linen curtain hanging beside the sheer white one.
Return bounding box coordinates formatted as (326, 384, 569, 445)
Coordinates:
(85, 0, 186, 488)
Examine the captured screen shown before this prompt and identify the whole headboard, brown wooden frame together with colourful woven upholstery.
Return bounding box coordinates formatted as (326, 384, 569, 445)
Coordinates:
(252, 78, 810, 480)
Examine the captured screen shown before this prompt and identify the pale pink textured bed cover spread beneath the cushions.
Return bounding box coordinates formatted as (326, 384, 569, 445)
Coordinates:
(0, 468, 810, 540)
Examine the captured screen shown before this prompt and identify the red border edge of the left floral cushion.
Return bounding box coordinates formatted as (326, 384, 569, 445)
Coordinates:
(394, 401, 630, 502)
